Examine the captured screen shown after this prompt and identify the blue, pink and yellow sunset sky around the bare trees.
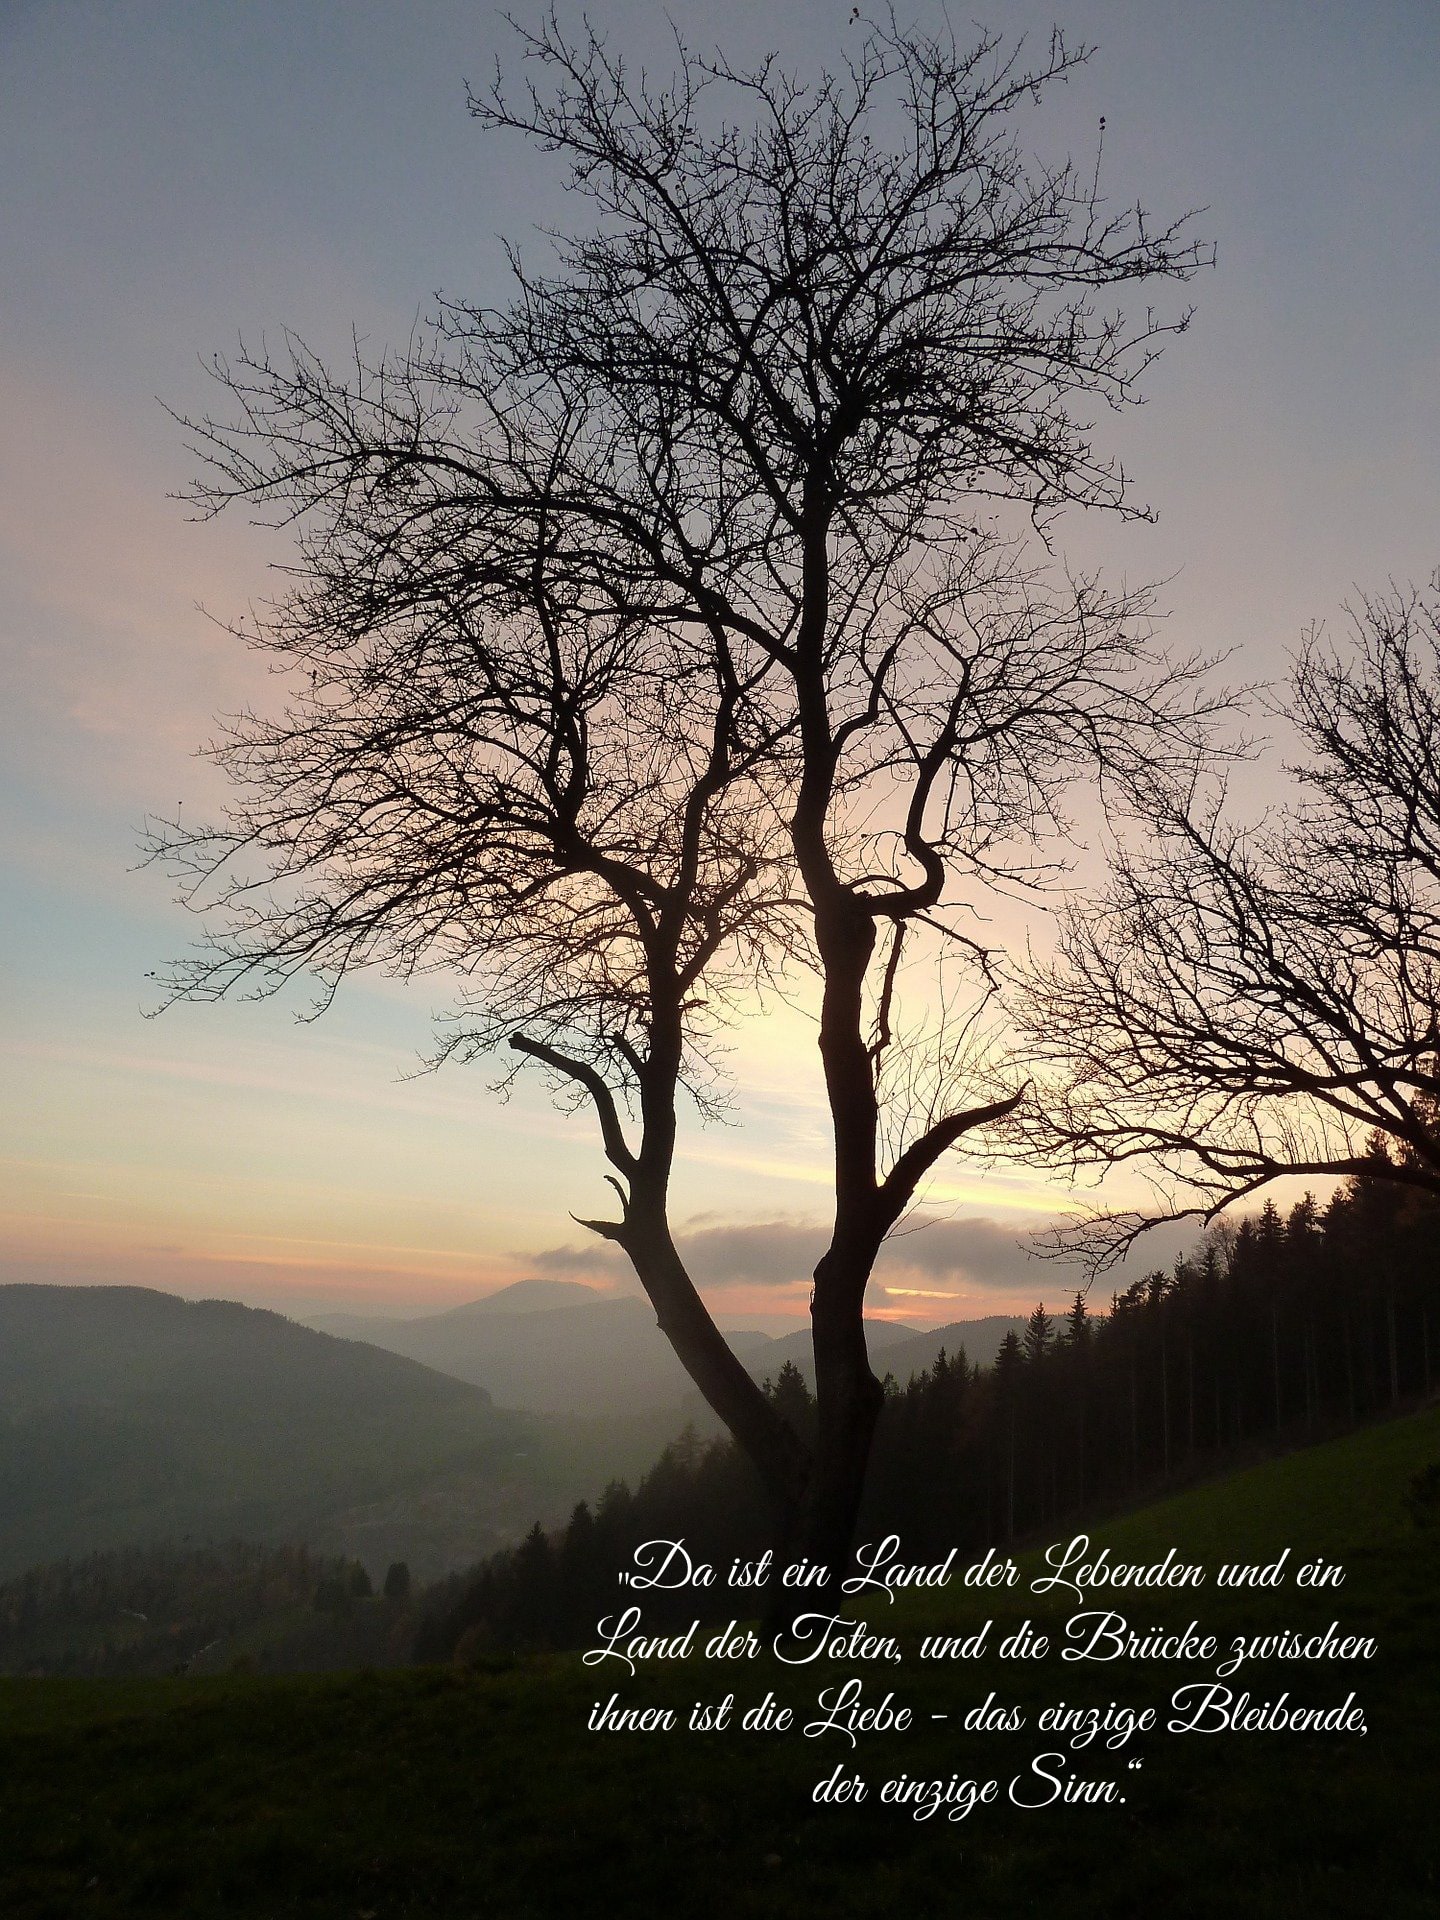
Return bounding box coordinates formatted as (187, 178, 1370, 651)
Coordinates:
(0, 0, 1440, 1327)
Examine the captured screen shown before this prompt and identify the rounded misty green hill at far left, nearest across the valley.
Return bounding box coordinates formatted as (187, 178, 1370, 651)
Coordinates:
(0, 1286, 540, 1572)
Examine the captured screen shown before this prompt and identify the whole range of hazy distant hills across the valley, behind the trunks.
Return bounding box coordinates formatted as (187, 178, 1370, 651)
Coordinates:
(0, 1281, 1013, 1578)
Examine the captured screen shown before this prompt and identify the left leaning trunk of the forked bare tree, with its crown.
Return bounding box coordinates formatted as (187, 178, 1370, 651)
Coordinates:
(156, 382, 804, 1501)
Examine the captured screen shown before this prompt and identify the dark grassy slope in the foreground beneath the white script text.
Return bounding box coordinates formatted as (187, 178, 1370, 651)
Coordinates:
(0, 1411, 1440, 1920)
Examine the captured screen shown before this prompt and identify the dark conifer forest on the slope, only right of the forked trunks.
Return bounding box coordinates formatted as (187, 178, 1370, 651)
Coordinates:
(866, 1144, 1440, 1549)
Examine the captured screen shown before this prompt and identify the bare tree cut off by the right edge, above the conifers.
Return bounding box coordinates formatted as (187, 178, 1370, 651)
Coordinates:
(1025, 578, 1440, 1254)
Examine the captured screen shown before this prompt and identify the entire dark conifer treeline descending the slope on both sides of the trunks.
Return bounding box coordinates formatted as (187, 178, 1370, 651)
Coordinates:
(415, 1144, 1440, 1659)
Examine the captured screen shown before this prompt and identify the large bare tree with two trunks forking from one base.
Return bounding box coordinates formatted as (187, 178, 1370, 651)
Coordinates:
(152, 17, 1204, 1589)
